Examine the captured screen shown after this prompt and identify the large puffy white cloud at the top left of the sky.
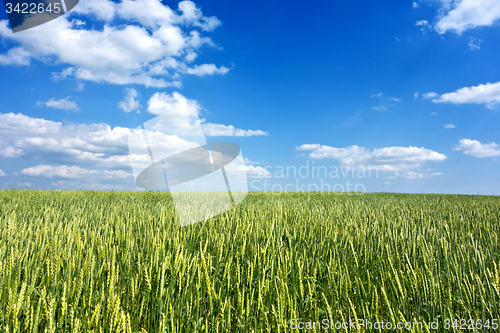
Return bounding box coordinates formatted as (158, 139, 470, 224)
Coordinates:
(0, 0, 229, 87)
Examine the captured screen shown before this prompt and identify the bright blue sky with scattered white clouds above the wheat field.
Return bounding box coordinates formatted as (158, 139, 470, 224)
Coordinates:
(0, 0, 500, 195)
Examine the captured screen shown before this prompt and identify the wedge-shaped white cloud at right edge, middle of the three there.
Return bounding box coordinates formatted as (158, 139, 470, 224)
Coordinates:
(432, 82, 500, 108)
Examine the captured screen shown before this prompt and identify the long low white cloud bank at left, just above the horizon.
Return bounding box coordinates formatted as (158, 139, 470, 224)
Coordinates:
(0, 113, 243, 189)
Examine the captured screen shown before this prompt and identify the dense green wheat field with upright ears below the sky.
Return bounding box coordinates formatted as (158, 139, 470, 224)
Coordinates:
(0, 190, 500, 332)
